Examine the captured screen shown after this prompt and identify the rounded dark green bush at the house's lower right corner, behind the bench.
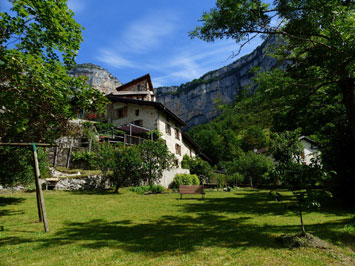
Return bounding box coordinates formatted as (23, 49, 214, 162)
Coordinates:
(181, 154, 212, 184)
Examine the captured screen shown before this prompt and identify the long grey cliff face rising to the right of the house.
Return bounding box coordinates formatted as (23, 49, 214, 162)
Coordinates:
(156, 39, 276, 128)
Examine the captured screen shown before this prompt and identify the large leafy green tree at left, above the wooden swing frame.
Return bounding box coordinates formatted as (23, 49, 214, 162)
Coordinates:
(0, 0, 105, 142)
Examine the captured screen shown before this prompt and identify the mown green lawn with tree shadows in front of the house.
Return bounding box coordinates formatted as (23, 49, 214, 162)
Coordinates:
(0, 189, 355, 265)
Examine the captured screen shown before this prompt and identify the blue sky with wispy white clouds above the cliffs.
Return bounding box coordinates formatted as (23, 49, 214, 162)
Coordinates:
(0, 0, 260, 87)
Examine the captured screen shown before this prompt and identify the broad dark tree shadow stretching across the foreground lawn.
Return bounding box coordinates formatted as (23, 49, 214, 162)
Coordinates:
(31, 214, 354, 253)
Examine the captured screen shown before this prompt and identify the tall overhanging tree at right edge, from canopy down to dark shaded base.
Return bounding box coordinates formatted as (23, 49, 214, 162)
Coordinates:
(191, 0, 355, 202)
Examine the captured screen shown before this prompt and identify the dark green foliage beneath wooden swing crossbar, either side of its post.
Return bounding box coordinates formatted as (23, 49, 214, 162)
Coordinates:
(0, 146, 49, 187)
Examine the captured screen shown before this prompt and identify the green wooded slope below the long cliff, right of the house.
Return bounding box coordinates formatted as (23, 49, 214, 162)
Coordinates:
(188, 95, 271, 165)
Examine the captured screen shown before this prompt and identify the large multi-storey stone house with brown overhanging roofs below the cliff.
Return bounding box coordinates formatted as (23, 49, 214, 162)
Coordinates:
(106, 74, 199, 187)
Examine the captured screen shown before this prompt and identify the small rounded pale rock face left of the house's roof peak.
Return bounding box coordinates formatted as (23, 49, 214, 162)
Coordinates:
(69, 63, 122, 94)
